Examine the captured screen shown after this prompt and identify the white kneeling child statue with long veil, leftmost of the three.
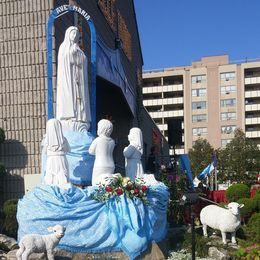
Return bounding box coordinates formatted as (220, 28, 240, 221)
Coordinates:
(44, 118, 70, 188)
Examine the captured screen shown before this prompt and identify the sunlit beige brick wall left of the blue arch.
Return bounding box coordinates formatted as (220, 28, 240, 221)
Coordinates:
(0, 0, 52, 203)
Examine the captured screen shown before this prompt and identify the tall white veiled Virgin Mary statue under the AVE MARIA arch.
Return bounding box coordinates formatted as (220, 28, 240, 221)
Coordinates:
(56, 26, 91, 130)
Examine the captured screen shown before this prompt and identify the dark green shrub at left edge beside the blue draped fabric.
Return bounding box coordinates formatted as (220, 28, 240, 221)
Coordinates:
(3, 199, 18, 238)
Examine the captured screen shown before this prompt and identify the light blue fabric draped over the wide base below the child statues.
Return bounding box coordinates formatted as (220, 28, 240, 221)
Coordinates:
(17, 183, 169, 259)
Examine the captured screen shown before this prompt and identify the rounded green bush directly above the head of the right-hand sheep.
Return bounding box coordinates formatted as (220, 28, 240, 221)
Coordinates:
(226, 183, 250, 202)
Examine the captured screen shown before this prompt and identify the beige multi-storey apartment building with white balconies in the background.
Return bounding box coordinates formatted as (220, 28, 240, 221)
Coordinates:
(143, 55, 260, 153)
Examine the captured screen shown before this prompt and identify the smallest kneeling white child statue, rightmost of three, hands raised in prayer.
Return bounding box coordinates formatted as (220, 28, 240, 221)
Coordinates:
(123, 127, 144, 181)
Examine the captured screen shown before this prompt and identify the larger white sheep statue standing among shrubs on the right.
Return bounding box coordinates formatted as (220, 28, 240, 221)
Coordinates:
(200, 202, 244, 244)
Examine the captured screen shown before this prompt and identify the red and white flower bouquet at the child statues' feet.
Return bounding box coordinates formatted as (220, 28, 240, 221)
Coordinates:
(91, 173, 149, 205)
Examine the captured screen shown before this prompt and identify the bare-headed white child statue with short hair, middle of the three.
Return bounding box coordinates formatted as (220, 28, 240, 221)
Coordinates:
(89, 119, 115, 185)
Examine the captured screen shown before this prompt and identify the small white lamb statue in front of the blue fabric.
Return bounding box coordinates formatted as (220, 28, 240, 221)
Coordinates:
(16, 225, 65, 260)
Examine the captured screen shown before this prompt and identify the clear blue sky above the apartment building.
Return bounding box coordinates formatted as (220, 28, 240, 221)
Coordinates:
(134, 0, 260, 69)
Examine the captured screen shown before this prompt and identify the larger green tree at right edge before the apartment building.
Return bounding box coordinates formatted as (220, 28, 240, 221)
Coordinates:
(218, 129, 260, 183)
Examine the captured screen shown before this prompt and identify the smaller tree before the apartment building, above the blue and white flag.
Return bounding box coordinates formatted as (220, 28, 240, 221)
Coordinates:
(188, 138, 214, 176)
